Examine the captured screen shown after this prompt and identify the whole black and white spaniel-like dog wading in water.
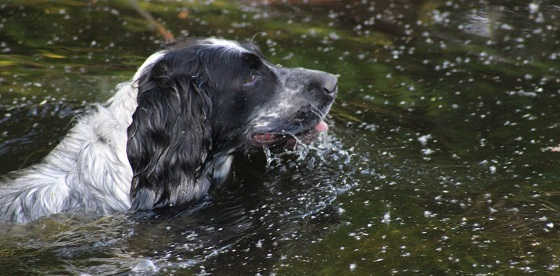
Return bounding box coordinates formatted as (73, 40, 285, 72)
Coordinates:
(0, 38, 337, 223)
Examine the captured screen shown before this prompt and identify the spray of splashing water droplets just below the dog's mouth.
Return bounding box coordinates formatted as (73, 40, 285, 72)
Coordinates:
(263, 130, 359, 223)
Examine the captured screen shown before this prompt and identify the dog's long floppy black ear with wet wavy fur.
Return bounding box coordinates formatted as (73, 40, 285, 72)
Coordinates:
(127, 60, 212, 210)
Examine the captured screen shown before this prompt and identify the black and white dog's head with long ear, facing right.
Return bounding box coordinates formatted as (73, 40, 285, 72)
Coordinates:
(127, 39, 337, 209)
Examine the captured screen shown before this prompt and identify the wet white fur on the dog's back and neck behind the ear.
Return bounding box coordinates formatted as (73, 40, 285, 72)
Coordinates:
(0, 89, 132, 223)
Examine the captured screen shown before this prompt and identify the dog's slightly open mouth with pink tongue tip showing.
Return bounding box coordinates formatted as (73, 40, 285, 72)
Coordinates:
(252, 120, 329, 145)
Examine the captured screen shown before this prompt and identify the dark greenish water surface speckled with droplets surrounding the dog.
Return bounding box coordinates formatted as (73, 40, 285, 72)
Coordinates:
(0, 0, 560, 275)
